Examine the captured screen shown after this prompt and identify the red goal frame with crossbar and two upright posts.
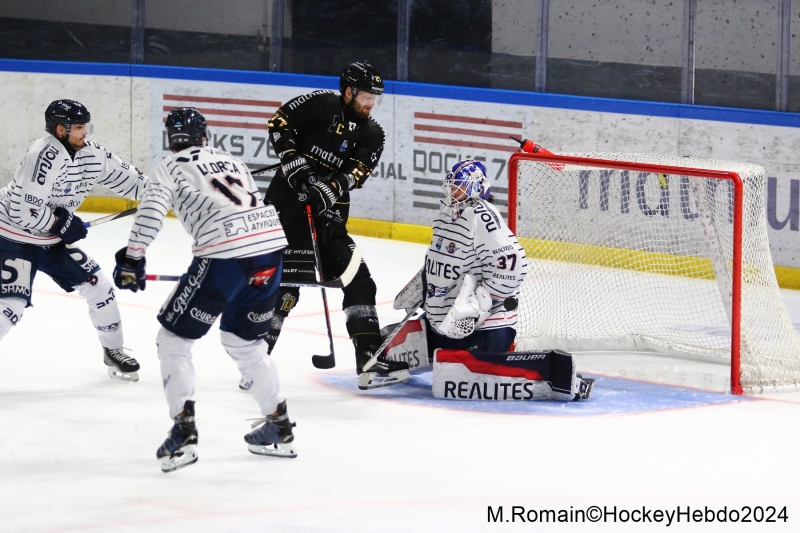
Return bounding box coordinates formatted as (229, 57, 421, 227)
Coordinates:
(508, 151, 744, 394)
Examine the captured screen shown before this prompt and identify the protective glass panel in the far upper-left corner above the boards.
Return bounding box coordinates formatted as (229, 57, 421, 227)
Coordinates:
(0, 0, 131, 63)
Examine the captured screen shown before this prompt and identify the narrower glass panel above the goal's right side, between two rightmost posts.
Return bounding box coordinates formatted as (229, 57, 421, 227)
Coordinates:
(694, 0, 778, 109)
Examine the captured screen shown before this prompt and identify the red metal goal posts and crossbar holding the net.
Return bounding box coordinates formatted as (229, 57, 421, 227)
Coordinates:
(508, 148, 764, 394)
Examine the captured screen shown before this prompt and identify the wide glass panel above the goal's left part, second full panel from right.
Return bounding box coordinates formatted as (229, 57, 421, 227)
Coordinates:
(546, 0, 684, 102)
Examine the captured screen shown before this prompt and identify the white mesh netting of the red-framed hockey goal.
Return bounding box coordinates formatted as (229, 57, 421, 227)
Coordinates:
(510, 153, 800, 391)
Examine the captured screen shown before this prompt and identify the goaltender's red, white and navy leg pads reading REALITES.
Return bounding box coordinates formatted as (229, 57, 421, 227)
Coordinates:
(382, 318, 594, 401)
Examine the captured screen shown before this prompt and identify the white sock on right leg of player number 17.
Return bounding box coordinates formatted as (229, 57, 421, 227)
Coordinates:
(220, 331, 283, 416)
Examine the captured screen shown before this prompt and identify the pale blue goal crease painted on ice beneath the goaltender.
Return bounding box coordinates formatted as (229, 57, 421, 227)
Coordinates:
(318, 372, 752, 416)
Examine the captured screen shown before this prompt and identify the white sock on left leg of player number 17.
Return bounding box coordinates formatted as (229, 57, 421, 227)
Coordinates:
(156, 327, 195, 418)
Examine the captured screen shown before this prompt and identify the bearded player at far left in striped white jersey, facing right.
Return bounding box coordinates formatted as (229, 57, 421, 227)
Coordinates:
(0, 100, 146, 381)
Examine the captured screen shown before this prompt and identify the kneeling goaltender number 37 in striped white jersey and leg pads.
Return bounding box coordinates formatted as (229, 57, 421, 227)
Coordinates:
(384, 159, 593, 400)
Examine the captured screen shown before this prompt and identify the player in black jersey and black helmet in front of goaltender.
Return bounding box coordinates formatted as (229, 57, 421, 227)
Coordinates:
(250, 63, 410, 388)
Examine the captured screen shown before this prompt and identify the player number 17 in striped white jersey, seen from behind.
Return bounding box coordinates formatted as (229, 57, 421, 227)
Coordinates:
(114, 107, 297, 472)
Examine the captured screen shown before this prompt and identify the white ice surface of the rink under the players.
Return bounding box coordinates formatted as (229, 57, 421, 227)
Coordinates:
(0, 215, 800, 532)
